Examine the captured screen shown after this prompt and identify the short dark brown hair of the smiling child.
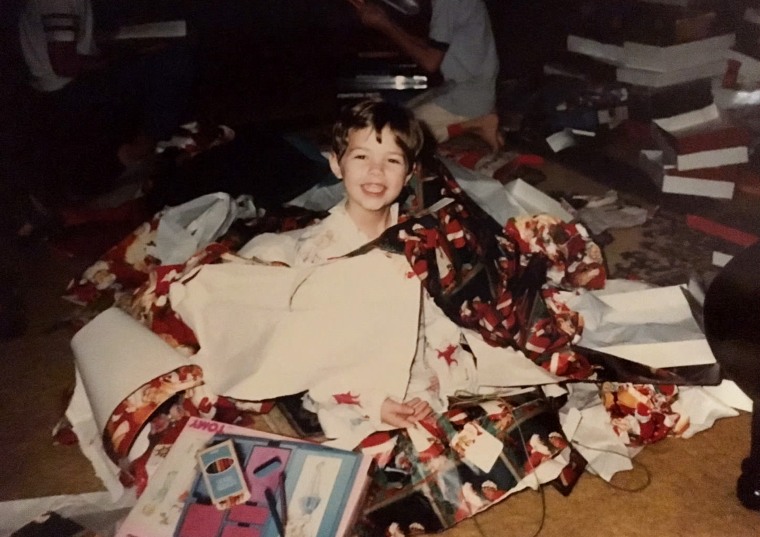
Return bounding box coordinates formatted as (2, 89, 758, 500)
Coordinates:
(332, 100, 424, 171)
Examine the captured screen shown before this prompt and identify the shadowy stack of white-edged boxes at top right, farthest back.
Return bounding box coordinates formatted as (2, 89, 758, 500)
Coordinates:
(567, 1, 736, 120)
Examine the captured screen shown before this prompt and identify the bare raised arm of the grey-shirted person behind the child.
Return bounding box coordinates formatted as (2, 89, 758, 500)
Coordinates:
(348, 0, 446, 74)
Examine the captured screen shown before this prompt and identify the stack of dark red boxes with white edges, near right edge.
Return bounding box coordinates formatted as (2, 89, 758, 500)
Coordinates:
(639, 104, 752, 199)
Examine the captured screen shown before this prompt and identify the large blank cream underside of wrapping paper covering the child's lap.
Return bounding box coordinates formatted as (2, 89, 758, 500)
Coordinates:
(169, 251, 421, 410)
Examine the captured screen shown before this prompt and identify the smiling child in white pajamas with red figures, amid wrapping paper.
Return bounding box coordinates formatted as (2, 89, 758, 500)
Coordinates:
(238, 101, 475, 434)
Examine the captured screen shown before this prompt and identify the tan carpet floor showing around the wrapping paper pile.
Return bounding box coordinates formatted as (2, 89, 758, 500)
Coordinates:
(0, 153, 760, 537)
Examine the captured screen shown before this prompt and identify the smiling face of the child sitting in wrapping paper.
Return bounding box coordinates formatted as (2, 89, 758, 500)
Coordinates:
(330, 127, 411, 222)
